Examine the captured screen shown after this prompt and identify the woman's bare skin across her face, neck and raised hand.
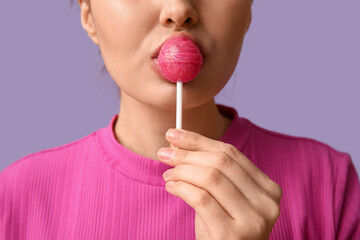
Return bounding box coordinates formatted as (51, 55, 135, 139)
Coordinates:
(79, 0, 281, 239)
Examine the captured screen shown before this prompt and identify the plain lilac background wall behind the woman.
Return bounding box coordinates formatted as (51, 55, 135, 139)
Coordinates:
(0, 0, 360, 172)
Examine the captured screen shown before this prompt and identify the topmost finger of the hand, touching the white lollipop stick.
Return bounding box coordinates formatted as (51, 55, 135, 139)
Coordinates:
(166, 128, 282, 202)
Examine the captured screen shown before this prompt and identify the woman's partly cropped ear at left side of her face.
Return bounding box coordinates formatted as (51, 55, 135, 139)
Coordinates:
(78, 0, 99, 45)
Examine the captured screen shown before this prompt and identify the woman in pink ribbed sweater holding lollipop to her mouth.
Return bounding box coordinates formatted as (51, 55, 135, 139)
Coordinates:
(0, 0, 360, 239)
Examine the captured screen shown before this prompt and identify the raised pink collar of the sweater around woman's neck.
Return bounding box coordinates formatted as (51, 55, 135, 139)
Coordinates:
(95, 104, 251, 186)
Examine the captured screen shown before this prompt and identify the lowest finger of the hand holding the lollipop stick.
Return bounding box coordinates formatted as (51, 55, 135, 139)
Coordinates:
(165, 181, 235, 239)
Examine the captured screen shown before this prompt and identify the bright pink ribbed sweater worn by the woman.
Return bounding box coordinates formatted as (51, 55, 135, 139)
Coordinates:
(0, 105, 360, 240)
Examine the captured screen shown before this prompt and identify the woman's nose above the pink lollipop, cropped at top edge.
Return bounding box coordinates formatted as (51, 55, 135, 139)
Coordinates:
(160, 0, 198, 30)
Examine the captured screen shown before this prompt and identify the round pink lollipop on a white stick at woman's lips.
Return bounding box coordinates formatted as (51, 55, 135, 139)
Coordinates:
(158, 37, 203, 128)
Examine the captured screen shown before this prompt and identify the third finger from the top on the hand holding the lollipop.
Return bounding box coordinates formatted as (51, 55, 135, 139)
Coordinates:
(164, 164, 254, 219)
